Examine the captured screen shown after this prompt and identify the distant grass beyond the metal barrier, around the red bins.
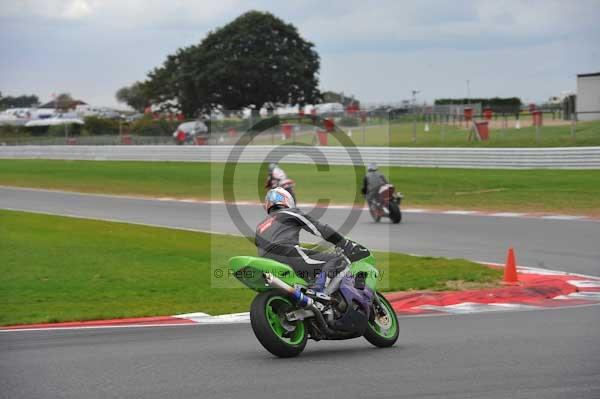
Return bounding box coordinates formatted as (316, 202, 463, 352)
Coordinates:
(244, 118, 600, 148)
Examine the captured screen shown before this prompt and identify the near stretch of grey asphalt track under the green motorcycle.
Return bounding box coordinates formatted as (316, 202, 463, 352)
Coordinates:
(0, 307, 600, 399)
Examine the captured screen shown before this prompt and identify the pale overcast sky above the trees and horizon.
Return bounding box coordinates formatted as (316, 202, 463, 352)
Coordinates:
(0, 0, 600, 106)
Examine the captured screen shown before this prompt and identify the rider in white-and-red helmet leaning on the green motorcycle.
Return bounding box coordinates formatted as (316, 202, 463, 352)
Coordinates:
(255, 187, 358, 292)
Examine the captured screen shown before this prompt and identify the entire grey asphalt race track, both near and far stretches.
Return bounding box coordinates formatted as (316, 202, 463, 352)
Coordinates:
(0, 188, 600, 399)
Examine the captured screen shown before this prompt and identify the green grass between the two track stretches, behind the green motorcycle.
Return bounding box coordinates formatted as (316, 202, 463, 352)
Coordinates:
(0, 210, 500, 326)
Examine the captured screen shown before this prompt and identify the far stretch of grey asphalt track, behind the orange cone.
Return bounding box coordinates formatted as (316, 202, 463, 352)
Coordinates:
(0, 187, 600, 276)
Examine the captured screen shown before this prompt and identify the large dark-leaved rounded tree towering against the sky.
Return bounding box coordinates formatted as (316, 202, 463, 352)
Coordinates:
(145, 11, 320, 115)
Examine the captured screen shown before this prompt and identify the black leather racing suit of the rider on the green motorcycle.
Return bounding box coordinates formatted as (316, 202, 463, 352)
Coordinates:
(255, 208, 345, 281)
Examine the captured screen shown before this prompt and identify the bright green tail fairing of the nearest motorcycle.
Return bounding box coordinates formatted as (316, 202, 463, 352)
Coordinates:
(229, 256, 307, 292)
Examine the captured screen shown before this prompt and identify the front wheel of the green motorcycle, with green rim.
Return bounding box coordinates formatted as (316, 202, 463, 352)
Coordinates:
(364, 292, 400, 348)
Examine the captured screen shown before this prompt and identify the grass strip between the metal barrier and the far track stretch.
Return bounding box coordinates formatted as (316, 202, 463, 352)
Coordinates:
(0, 160, 600, 215)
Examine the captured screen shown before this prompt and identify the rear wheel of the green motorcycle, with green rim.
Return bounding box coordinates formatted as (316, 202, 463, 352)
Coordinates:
(250, 291, 308, 357)
